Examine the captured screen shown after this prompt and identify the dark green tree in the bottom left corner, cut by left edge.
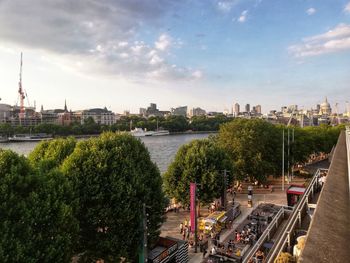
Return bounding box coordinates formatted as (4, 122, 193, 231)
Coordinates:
(0, 150, 78, 263)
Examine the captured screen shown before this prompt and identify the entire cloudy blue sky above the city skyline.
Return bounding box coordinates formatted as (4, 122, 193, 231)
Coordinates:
(0, 0, 350, 113)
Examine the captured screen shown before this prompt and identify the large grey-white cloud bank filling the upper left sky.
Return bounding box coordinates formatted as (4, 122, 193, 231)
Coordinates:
(0, 0, 200, 81)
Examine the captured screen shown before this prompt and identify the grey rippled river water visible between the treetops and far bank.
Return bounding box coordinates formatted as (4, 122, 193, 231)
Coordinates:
(0, 134, 209, 173)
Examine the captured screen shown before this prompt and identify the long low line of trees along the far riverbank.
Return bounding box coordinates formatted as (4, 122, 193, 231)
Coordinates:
(0, 115, 231, 136)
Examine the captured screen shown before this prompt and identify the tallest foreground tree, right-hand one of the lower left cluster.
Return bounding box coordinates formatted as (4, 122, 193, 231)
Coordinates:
(62, 133, 165, 262)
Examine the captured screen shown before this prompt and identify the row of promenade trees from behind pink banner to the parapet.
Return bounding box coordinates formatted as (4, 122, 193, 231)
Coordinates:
(164, 119, 344, 210)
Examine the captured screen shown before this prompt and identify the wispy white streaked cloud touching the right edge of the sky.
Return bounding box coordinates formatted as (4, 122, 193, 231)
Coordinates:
(288, 24, 350, 58)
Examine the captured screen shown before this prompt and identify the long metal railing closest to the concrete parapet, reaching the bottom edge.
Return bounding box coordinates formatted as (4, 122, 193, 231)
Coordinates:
(266, 169, 328, 262)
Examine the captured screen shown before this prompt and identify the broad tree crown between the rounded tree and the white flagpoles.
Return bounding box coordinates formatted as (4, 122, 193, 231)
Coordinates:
(217, 119, 282, 182)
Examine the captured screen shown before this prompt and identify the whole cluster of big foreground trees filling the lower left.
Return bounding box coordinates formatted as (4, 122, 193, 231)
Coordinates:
(0, 133, 166, 262)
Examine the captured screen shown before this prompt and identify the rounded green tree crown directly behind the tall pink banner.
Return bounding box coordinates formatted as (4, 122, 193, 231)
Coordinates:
(164, 139, 232, 205)
